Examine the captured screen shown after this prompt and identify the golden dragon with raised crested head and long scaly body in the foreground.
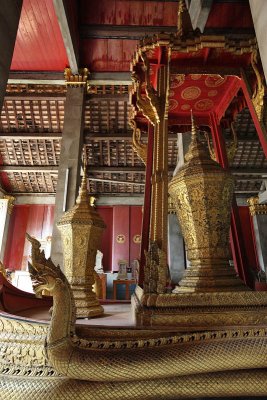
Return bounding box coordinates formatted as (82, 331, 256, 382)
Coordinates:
(0, 235, 267, 400)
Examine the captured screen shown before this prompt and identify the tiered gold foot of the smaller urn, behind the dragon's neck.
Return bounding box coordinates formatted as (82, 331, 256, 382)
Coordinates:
(72, 286, 104, 318)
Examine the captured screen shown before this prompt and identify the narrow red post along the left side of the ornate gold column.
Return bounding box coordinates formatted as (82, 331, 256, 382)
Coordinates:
(138, 123, 154, 286)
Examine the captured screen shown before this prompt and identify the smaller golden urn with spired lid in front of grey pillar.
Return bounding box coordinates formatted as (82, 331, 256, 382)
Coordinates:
(57, 162, 106, 318)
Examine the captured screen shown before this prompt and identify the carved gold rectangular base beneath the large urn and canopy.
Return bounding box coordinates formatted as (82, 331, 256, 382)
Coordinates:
(132, 287, 267, 331)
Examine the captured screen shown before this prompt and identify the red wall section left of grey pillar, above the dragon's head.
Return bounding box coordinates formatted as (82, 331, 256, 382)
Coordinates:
(4, 204, 55, 270)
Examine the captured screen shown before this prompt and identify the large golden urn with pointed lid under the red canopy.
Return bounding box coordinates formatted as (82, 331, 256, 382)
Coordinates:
(169, 116, 244, 293)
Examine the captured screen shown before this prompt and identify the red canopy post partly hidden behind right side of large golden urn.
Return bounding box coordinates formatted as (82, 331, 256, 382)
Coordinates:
(210, 113, 252, 286)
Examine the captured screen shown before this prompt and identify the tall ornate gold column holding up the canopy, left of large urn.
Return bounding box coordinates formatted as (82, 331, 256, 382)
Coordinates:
(137, 47, 170, 293)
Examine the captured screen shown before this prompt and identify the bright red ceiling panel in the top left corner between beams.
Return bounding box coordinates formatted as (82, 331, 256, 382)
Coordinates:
(11, 0, 68, 71)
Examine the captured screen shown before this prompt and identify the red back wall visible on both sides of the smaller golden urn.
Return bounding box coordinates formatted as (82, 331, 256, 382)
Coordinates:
(4, 204, 142, 272)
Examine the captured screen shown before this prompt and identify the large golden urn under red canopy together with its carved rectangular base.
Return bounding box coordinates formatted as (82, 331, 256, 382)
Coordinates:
(132, 115, 267, 330)
